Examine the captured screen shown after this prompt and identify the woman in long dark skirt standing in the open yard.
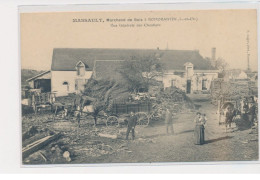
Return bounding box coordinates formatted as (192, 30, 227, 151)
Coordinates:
(194, 112, 206, 145)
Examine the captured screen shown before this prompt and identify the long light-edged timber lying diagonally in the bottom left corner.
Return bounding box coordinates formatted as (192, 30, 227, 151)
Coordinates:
(22, 133, 61, 158)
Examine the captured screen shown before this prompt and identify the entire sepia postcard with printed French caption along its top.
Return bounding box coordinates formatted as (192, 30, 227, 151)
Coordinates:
(19, 9, 259, 166)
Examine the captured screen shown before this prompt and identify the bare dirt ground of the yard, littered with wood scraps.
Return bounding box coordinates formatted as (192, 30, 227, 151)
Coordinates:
(23, 95, 258, 164)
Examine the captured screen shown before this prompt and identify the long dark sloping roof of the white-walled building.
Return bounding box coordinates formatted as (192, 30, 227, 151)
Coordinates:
(51, 48, 214, 71)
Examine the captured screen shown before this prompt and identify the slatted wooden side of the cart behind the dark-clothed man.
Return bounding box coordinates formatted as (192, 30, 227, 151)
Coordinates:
(112, 101, 152, 114)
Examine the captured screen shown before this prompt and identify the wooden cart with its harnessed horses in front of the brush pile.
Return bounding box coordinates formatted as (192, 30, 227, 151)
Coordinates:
(50, 96, 152, 126)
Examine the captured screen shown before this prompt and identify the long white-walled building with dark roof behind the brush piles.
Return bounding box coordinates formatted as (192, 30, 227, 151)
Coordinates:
(27, 48, 217, 96)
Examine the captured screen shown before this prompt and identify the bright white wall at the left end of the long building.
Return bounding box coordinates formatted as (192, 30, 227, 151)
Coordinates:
(51, 71, 92, 96)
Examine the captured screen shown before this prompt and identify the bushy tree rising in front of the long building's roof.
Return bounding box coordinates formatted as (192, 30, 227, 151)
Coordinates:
(119, 56, 162, 92)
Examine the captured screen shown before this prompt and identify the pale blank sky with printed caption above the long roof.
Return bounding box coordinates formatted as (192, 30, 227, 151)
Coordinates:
(20, 9, 258, 70)
